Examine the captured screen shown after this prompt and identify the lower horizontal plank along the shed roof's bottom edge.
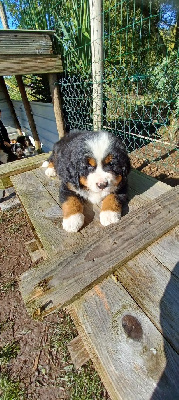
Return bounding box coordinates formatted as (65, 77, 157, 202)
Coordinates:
(0, 54, 63, 76)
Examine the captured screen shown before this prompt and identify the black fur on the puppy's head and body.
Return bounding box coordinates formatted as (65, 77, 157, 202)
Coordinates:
(49, 131, 130, 204)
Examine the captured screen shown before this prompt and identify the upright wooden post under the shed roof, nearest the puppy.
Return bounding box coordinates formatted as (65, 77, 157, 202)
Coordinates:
(49, 73, 65, 138)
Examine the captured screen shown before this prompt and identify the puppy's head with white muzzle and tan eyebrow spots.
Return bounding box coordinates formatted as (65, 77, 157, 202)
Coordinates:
(79, 131, 130, 197)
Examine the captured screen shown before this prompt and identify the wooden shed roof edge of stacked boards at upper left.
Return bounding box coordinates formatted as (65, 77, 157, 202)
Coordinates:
(0, 30, 62, 76)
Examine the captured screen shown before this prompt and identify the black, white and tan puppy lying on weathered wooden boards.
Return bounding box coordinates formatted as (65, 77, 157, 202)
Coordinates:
(43, 130, 130, 232)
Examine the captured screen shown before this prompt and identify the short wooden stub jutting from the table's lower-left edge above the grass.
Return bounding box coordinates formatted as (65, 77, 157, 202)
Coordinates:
(68, 335, 90, 369)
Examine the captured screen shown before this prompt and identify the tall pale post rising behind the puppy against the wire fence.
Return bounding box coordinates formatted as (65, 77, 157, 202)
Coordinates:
(89, 0, 103, 131)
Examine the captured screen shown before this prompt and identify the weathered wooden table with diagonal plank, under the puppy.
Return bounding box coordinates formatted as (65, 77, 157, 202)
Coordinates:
(3, 159, 179, 400)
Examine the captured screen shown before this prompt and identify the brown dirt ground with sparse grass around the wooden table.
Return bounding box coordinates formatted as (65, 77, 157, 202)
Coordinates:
(0, 145, 179, 400)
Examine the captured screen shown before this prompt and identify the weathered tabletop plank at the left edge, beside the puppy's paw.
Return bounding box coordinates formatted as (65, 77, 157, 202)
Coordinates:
(11, 171, 80, 256)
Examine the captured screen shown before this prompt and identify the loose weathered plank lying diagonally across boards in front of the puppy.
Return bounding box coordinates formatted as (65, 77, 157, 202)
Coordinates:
(20, 187, 179, 313)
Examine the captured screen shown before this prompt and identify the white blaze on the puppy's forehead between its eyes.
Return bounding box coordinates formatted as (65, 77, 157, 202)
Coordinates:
(87, 132, 110, 164)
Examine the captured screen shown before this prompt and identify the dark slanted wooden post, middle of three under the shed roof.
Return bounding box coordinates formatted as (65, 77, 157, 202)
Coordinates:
(16, 75, 41, 151)
